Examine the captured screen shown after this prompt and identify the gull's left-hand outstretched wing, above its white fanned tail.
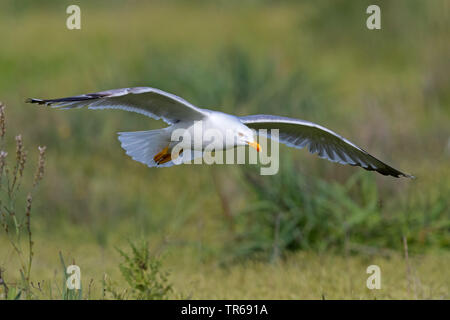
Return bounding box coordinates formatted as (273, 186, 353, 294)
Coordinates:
(26, 87, 206, 124)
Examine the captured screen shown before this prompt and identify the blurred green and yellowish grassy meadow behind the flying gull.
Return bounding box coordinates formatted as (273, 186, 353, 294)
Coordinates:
(0, 0, 450, 299)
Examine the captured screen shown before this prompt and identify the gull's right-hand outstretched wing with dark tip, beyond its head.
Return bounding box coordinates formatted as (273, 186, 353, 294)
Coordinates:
(240, 115, 414, 178)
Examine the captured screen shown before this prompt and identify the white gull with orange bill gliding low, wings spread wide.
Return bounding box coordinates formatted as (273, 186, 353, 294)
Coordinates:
(26, 87, 414, 178)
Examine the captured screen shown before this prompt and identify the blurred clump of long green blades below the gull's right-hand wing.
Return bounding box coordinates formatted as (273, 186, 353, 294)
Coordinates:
(228, 161, 450, 260)
